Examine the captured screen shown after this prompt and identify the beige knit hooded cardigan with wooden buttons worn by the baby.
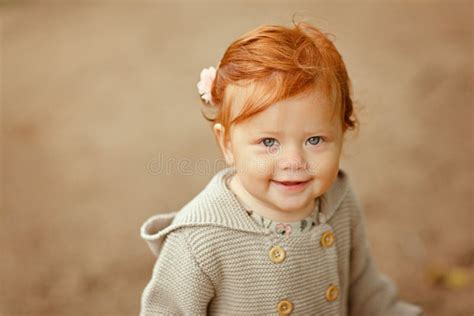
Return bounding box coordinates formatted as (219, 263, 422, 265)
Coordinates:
(140, 167, 422, 316)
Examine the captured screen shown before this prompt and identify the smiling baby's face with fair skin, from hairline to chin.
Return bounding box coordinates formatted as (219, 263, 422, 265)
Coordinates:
(216, 87, 343, 212)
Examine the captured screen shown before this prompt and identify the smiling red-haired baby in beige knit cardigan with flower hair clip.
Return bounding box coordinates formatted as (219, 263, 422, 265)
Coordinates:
(141, 22, 422, 316)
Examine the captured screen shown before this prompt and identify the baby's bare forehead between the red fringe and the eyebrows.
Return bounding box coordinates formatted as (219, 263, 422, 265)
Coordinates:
(231, 90, 339, 132)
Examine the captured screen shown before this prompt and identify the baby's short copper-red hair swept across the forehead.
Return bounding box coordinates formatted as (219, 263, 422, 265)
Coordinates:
(203, 22, 358, 139)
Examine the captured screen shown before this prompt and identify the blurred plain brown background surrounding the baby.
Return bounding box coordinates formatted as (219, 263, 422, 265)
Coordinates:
(0, 0, 474, 316)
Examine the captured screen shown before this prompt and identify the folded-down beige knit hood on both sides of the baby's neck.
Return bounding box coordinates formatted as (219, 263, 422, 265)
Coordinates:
(140, 167, 349, 256)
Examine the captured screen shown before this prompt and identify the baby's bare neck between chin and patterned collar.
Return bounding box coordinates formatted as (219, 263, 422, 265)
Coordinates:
(227, 174, 315, 222)
